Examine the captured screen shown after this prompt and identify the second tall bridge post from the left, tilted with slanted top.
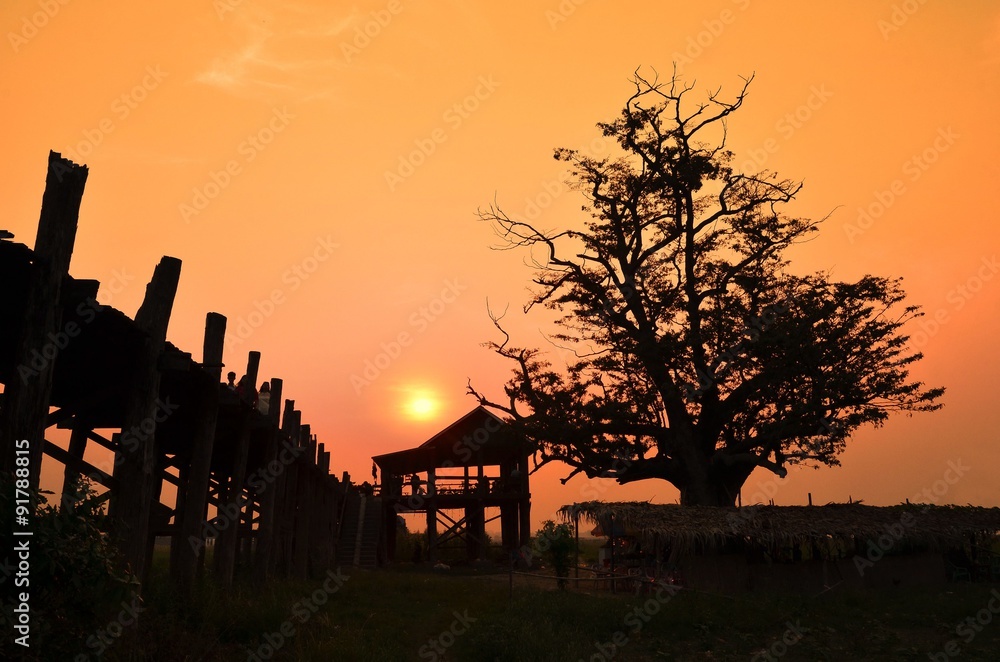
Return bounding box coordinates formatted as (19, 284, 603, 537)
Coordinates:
(109, 257, 181, 580)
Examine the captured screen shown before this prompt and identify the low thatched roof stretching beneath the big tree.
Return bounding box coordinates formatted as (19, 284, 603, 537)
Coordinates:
(559, 501, 1000, 549)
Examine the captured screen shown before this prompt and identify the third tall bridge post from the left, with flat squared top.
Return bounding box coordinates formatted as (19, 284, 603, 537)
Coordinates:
(170, 313, 226, 596)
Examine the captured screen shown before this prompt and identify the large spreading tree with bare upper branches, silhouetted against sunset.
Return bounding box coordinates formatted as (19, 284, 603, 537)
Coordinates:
(469, 73, 943, 505)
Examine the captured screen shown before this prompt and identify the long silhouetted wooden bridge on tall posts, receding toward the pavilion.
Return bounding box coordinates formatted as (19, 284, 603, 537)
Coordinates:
(0, 153, 357, 592)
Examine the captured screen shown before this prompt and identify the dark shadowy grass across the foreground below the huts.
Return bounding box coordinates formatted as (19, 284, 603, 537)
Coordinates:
(68, 567, 1000, 661)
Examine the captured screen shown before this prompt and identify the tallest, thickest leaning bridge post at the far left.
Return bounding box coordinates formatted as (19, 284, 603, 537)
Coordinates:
(0, 152, 87, 489)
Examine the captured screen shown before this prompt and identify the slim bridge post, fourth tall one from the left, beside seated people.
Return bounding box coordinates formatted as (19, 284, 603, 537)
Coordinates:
(215, 352, 260, 586)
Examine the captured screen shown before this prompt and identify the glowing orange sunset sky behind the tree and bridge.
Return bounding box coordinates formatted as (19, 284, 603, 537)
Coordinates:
(0, 0, 1000, 523)
